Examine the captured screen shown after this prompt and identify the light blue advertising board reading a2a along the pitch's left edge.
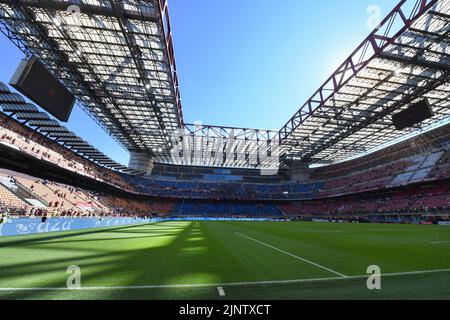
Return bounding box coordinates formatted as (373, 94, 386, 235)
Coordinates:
(0, 218, 150, 236)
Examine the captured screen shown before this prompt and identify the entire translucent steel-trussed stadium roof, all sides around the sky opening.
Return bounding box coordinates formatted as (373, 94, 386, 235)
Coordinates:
(0, 0, 450, 168)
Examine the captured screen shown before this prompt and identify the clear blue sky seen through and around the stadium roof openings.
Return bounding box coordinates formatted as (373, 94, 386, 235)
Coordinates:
(0, 0, 398, 164)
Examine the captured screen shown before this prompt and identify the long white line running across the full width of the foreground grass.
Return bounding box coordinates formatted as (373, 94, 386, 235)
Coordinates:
(0, 268, 450, 292)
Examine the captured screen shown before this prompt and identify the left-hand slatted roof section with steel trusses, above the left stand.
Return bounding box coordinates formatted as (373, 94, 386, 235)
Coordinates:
(0, 0, 183, 151)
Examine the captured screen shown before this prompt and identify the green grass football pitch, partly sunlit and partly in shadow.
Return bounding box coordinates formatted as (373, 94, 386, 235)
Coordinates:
(0, 221, 450, 299)
